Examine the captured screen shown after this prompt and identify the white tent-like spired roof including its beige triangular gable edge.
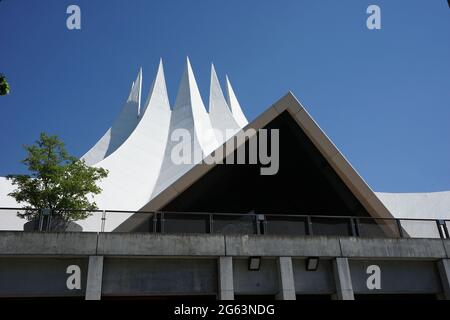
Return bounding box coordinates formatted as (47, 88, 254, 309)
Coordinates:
(0, 59, 450, 231)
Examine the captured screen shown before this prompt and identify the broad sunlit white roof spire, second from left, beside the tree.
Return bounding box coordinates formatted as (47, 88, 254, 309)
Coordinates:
(95, 60, 171, 215)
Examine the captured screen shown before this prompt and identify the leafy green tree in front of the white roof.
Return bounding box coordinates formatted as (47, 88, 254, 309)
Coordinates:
(7, 133, 108, 221)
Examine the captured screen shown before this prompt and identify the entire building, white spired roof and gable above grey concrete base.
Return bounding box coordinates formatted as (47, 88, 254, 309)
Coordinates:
(0, 60, 450, 300)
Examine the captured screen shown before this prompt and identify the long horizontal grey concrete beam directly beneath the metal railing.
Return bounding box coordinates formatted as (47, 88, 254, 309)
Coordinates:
(0, 231, 450, 260)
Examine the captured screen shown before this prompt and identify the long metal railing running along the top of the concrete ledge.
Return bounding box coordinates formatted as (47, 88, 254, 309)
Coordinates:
(0, 208, 450, 239)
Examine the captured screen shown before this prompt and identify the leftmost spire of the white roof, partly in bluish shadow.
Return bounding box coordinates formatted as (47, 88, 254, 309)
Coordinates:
(81, 69, 142, 166)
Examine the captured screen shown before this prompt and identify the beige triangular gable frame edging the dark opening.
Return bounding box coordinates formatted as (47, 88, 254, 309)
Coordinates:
(115, 92, 393, 231)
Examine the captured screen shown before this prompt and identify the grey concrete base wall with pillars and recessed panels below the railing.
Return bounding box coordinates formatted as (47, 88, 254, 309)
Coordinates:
(0, 232, 450, 299)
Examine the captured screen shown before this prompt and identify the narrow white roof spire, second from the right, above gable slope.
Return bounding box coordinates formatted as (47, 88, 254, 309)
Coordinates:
(209, 64, 240, 144)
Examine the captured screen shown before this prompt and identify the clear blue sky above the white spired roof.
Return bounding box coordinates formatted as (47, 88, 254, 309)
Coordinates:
(0, 0, 450, 192)
